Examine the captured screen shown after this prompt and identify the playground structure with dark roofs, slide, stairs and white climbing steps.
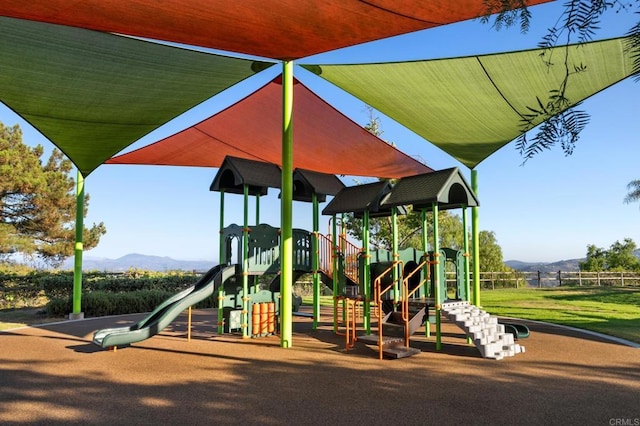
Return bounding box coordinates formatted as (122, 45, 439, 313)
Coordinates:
(94, 157, 528, 359)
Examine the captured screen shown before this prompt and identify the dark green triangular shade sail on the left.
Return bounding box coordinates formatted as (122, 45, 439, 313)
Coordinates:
(0, 17, 272, 176)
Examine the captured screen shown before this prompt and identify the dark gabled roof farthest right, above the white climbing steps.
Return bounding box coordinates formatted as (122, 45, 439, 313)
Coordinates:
(381, 167, 479, 210)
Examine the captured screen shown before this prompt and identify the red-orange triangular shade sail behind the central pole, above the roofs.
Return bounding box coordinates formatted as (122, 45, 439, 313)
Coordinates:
(107, 78, 431, 178)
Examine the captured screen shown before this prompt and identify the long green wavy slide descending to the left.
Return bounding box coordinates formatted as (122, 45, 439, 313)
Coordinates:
(93, 265, 236, 348)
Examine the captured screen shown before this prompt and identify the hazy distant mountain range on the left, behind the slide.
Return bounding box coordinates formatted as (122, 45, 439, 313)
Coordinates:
(60, 253, 217, 272)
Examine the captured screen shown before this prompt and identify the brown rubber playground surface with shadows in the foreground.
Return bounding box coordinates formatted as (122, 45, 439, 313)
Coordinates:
(0, 310, 640, 425)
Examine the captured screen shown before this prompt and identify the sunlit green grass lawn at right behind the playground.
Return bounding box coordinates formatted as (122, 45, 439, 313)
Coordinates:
(303, 287, 640, 343)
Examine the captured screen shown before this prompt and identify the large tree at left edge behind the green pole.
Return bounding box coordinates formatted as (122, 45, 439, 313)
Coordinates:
(0, 123, 106, 266)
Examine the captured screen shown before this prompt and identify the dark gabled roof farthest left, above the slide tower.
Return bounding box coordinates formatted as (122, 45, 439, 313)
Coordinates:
(209, 157, 282, 195)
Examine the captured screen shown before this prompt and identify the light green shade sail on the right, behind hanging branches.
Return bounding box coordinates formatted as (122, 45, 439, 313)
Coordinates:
(305, 38, 633, 168)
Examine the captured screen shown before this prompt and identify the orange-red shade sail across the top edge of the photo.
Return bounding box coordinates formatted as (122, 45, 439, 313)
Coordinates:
(0, 0, 549, 59)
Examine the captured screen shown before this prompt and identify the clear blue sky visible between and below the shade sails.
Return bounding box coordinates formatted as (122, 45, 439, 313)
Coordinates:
(0, 2, 640, 263)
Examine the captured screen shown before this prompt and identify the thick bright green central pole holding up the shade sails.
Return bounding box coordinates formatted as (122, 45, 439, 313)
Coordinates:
(280, 61, 293, 348)
